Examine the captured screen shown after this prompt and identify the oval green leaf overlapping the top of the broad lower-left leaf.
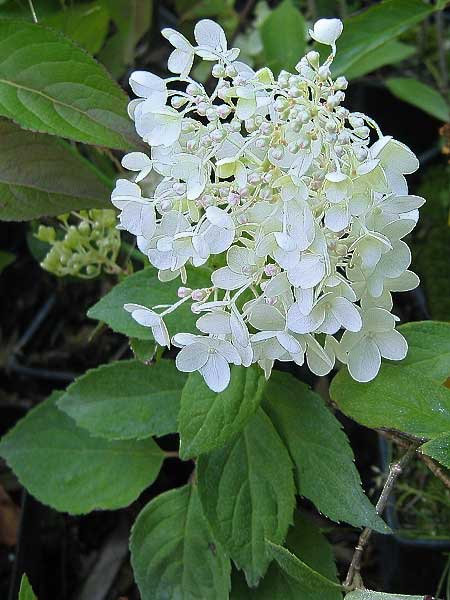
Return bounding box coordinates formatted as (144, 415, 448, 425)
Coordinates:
(58, 360, 186, 440)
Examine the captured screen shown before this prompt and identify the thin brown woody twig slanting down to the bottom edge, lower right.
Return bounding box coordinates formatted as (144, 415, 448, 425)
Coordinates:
(344, 442, 418, 590)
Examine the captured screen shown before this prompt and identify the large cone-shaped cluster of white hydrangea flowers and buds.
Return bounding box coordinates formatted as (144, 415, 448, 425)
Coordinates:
(112, 19, 424, 392)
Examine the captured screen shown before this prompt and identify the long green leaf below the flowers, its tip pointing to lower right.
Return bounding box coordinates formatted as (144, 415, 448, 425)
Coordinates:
(263, 372, 388, 533)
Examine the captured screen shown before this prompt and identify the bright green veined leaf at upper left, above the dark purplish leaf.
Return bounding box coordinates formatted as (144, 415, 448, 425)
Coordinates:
(0, 19, 138, 150)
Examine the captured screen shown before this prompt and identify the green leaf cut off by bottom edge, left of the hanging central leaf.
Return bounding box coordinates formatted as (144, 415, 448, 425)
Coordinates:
(130, 485, 230, 600)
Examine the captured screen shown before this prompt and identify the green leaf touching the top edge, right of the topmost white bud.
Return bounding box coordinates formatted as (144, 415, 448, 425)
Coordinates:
(332, 0, 434, 76)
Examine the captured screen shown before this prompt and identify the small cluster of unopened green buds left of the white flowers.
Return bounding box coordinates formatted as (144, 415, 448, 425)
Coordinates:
(36, 209, 120, 279)
